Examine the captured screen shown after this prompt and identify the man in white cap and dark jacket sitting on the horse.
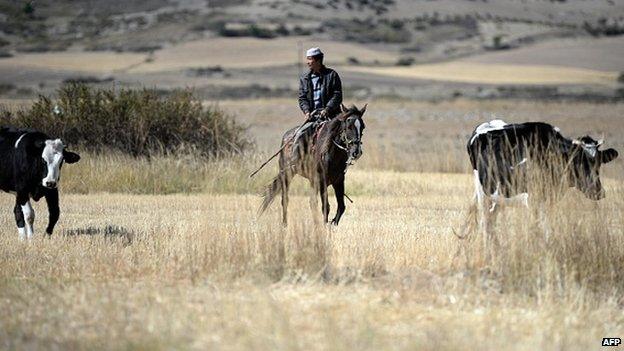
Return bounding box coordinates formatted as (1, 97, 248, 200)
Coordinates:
(292, 48, 342, 162)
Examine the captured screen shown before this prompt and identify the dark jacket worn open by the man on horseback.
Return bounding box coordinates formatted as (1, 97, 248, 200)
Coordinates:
(299, 66, 342, 116)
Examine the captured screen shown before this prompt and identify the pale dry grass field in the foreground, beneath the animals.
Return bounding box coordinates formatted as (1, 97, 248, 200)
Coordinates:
(0, 171, 624, 350)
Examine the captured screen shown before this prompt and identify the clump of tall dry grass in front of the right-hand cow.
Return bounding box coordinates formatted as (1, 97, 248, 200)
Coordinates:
(458, 144, 624, 299)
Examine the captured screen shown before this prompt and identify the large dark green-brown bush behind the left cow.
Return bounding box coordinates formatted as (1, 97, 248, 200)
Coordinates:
(0, 83, 250, 156)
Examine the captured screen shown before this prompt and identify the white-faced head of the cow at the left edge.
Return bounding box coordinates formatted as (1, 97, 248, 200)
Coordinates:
(35, 139, 80, 188)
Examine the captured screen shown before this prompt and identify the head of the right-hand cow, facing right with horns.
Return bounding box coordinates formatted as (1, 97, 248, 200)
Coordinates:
(569, 136, 618, 200)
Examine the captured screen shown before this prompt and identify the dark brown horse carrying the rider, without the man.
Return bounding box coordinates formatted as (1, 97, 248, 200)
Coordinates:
(259, 105, 366, 225)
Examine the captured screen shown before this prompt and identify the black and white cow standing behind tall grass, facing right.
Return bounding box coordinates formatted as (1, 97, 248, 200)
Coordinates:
(467, 119, 618, 211)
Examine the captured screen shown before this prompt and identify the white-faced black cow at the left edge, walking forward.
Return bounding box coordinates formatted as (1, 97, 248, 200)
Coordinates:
(0, 127, 80, 239)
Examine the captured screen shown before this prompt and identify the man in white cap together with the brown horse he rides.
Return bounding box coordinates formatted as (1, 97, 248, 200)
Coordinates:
(251, 48, 366, 224)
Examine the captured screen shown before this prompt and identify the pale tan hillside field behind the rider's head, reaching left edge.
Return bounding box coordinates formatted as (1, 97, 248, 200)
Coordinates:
(0, 37, 398, 74)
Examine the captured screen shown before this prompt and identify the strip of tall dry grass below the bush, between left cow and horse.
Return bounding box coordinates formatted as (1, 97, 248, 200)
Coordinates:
(62, 151, 270, 194)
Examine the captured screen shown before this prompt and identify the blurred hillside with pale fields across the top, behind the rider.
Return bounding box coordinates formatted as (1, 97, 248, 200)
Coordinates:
(0, 0, 624, 101)
